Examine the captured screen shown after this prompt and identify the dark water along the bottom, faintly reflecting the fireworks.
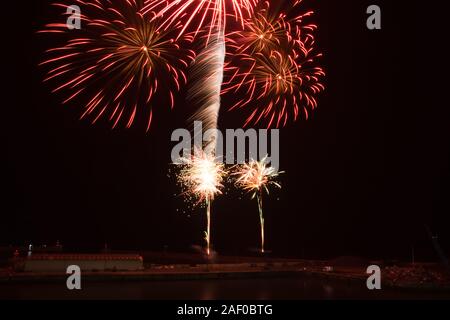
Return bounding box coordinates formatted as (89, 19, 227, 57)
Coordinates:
(0, 277, 450, 300)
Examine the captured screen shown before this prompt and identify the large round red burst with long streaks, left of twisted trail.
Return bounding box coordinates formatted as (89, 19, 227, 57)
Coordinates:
(40, 0, 195, 131)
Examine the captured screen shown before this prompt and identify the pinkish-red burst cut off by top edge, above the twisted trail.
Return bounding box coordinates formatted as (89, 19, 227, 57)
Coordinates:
(143, 0, 258, 36)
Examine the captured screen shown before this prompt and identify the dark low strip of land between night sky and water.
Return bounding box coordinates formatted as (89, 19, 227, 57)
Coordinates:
(0, 252, 450, 292)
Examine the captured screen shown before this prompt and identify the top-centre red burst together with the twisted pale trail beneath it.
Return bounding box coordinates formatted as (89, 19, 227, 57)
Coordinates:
(142, 0, 258, 150)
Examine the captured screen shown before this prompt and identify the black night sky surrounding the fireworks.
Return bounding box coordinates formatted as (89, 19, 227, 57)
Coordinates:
(0, 0, 450, 260)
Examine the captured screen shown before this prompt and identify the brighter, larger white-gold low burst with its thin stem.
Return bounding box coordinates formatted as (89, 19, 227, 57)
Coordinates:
(178, 149, 227, 255)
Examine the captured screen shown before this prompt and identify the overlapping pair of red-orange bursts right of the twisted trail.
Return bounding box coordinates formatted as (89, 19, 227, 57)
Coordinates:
(223, 1, 325, 128)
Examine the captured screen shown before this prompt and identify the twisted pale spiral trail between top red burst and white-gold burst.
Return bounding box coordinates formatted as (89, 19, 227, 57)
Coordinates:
(188, 31, 225, 153)
